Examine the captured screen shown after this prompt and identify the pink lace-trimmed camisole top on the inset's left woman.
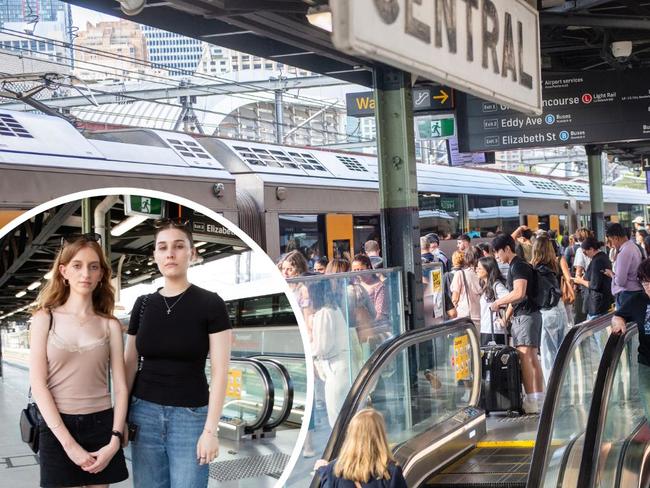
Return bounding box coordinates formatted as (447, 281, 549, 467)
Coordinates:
(47, 312, 112, 415)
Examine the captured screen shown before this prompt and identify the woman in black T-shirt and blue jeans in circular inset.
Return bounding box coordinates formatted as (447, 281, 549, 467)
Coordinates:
(125, 220, 231, 488)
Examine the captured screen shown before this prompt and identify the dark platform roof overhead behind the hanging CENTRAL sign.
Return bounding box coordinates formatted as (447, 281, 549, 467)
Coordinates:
(64, 0, 650, 155)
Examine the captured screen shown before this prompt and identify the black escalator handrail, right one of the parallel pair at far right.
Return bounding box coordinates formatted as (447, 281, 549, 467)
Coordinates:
(577, 324, 639, 488)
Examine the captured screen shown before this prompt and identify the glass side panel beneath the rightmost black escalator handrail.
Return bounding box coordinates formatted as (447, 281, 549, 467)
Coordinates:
(595, 334, 645, 488)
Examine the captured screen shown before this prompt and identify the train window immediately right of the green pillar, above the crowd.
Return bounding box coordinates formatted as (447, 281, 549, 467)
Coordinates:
(418, 193, 462, 238)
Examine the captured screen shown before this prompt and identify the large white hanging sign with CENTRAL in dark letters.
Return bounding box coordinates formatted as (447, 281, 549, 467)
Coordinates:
(329, 0, 542, 114)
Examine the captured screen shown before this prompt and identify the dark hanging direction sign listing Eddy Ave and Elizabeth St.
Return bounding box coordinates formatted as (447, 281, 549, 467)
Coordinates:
(457, 70, 650, 152)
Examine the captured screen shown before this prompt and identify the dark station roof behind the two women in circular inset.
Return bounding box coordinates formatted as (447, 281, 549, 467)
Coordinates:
(0, 200, 249, 318)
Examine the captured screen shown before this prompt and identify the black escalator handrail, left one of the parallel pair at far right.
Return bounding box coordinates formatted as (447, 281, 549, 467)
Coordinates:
(526, 313, 612, 488)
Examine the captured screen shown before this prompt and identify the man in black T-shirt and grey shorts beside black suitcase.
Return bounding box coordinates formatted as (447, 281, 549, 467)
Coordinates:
(490, 234, 544, 413)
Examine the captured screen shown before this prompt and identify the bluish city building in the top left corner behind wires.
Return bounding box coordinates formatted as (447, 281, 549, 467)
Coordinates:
(0, 0, 76, 66)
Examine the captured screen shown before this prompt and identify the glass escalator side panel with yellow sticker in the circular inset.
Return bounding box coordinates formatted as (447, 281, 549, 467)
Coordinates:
(205, 358, 270, 429)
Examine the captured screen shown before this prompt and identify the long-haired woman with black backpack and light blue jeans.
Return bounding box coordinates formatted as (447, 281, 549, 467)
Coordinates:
(531, 235, 569, 382)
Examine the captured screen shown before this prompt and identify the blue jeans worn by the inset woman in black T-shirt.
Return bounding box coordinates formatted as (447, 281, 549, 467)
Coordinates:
(129, 397, 209, 488)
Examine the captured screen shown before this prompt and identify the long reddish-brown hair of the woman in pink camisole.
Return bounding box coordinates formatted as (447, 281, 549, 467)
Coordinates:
(33, 238, 115, 318)
